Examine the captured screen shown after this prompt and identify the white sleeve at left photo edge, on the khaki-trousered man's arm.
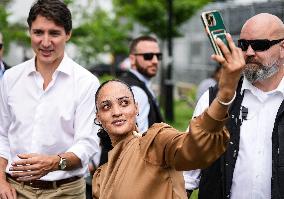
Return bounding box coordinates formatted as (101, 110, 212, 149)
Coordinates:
(0, 75, 11, 160)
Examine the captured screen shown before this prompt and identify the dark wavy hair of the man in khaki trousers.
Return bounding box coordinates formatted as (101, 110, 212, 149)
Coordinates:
(27, 0, 72, 34)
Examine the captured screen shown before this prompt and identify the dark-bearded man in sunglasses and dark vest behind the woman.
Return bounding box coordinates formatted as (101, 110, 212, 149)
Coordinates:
(120, 36, 163, 133)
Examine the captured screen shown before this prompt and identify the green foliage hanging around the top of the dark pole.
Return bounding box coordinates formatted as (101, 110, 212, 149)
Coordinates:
(113, 0, 210, 40)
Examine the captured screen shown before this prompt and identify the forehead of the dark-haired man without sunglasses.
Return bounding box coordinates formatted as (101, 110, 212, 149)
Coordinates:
(31, 15, 64, 30)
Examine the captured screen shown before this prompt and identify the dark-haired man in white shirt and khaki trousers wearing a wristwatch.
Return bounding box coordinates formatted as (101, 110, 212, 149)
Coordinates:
(0, 0, 99, 199)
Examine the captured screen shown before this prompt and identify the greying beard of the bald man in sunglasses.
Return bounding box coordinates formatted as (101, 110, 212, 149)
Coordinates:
(243, 57, 279, 84)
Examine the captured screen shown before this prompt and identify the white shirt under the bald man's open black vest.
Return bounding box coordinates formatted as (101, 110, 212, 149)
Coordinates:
(184, 78, 284, 199)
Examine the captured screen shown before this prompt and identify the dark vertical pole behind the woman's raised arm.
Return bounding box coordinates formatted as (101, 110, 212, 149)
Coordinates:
(165, 0, 174, 121)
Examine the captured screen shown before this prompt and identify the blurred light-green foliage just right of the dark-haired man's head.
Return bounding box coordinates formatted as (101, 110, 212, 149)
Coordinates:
(71, 9, 129, 64)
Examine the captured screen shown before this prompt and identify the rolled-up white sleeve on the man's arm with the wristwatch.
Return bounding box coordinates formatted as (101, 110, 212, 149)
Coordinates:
(67, 79, 100, 165)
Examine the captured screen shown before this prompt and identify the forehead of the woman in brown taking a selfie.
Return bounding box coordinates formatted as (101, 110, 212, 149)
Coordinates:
(98, 82, 132, 102)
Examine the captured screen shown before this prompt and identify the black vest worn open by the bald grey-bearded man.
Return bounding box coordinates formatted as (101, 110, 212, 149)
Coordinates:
(198, 78, 284, 199)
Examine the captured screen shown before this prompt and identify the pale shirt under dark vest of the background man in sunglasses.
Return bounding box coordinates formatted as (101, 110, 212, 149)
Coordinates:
(129, 69, 155, 133)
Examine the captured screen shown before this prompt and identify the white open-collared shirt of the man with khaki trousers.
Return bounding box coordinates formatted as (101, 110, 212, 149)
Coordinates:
(0, 54, 99, 181)
